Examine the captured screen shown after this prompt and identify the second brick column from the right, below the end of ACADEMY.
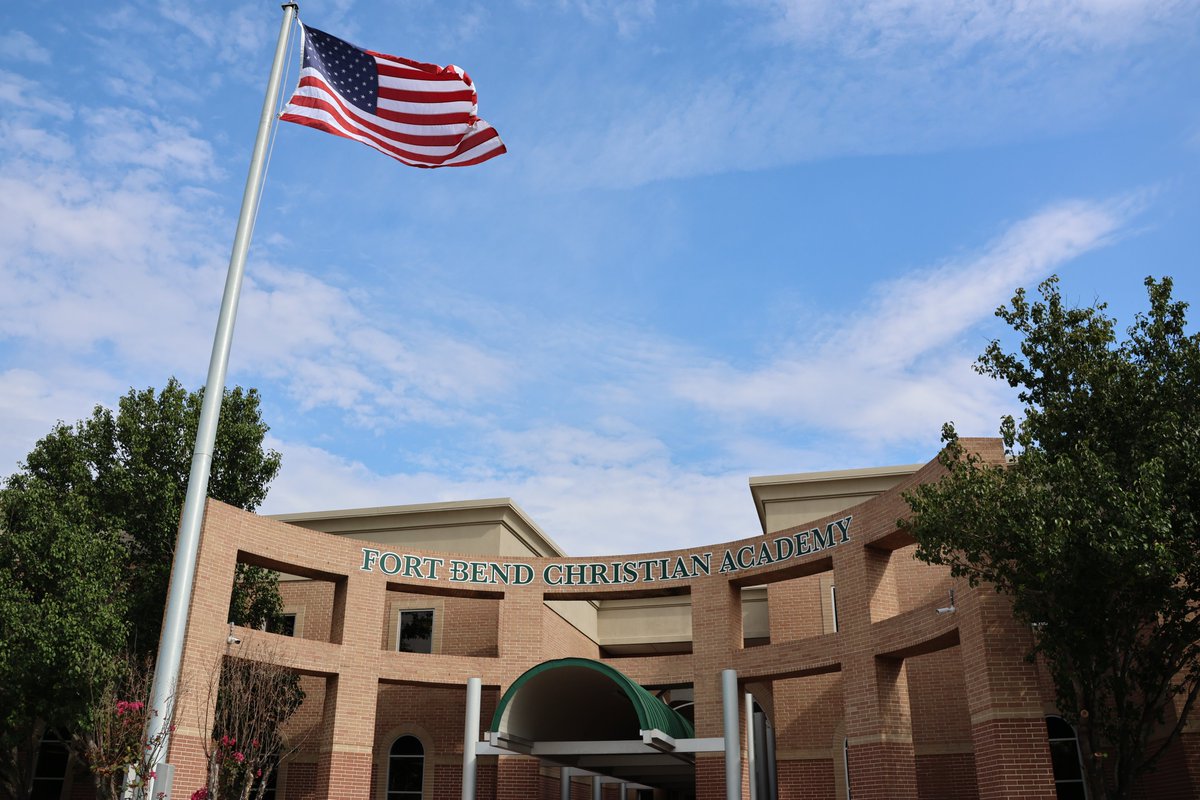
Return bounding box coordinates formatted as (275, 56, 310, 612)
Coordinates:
(834, 547, 917, 800)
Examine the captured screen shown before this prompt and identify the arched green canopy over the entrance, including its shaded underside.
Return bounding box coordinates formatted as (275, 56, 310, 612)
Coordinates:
(491, 658, 696, 741)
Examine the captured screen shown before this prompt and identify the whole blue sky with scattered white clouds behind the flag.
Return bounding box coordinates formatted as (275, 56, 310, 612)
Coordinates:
(0, 0, 1200, 554)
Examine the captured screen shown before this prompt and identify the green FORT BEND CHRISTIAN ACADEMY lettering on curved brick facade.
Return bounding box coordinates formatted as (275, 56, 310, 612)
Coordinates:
(360, 517, 852, 587)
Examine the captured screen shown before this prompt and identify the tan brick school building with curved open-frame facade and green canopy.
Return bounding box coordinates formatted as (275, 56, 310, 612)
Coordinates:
(145, 440, 1200, 800)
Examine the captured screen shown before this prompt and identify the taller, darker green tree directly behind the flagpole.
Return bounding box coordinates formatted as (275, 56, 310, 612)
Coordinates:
(6, 378, 280, 654)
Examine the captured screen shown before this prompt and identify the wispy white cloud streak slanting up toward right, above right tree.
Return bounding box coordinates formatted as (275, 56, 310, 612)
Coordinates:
(674, 199, 1139, 441)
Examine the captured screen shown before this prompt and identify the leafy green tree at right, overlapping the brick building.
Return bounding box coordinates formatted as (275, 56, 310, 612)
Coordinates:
(901, 278, 1200, 800)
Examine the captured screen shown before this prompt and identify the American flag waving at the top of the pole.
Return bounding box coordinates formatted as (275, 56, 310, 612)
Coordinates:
(280, 25, 505, 167)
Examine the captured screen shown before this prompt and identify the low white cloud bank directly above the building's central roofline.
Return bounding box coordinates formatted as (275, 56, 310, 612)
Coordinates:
(263, 426, 760, 555)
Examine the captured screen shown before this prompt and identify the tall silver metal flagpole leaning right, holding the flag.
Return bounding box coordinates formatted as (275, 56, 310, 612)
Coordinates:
(146, 2, 299, 786)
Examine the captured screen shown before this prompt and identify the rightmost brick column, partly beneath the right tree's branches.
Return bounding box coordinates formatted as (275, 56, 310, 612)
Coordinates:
(956, 587, 1056, 800)
